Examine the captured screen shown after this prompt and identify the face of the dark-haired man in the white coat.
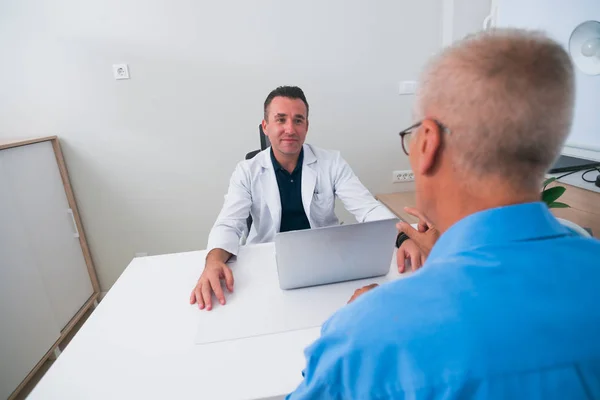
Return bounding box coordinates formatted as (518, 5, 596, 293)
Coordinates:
(262, 97, 308, 156)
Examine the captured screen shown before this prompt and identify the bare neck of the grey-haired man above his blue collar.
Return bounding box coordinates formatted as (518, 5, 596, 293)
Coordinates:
(435, 182, 540, 233)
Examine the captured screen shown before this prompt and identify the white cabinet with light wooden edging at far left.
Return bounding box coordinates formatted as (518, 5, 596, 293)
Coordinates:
(0, 137, 99, 399)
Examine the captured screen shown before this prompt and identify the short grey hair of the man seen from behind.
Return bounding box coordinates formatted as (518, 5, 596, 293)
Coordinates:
(417, 29, 575, 189)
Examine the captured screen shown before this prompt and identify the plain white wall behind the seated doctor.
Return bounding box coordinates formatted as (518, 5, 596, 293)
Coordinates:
(0, 0, 489, 295)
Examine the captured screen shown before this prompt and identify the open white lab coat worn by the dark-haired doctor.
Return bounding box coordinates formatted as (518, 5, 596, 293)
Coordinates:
(207, 144, 395, 255)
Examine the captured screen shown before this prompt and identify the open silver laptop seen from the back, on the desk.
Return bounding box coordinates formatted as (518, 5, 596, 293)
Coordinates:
(275, 219, 398, 289)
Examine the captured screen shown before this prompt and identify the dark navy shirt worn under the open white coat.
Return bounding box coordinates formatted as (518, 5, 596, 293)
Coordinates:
(271, 149, 310, 232)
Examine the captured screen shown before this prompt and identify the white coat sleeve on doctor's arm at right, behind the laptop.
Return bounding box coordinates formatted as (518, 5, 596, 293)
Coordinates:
(334, 154, 397, 222)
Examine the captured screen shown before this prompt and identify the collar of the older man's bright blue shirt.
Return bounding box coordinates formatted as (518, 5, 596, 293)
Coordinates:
(427, 202, 570, 263)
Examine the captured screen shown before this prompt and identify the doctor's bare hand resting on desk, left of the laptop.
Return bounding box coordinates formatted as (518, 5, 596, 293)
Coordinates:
(190, 249, 233, 311)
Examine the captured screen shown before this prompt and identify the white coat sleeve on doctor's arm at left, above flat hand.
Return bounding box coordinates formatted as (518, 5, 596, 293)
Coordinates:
(207, 163, 252, 255)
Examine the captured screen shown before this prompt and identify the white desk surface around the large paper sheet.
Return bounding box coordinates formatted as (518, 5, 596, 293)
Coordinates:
(29, 244, 399, 400)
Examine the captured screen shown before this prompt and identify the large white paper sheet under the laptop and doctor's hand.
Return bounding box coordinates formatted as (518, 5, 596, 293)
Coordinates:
(195, 247, 399, 344)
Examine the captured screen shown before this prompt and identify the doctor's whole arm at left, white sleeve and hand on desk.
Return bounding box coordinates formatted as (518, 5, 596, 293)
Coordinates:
(190, 164, 252, 311)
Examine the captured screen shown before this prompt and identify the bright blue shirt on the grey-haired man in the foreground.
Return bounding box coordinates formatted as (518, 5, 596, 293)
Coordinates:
(289, 203, 600, 400)
